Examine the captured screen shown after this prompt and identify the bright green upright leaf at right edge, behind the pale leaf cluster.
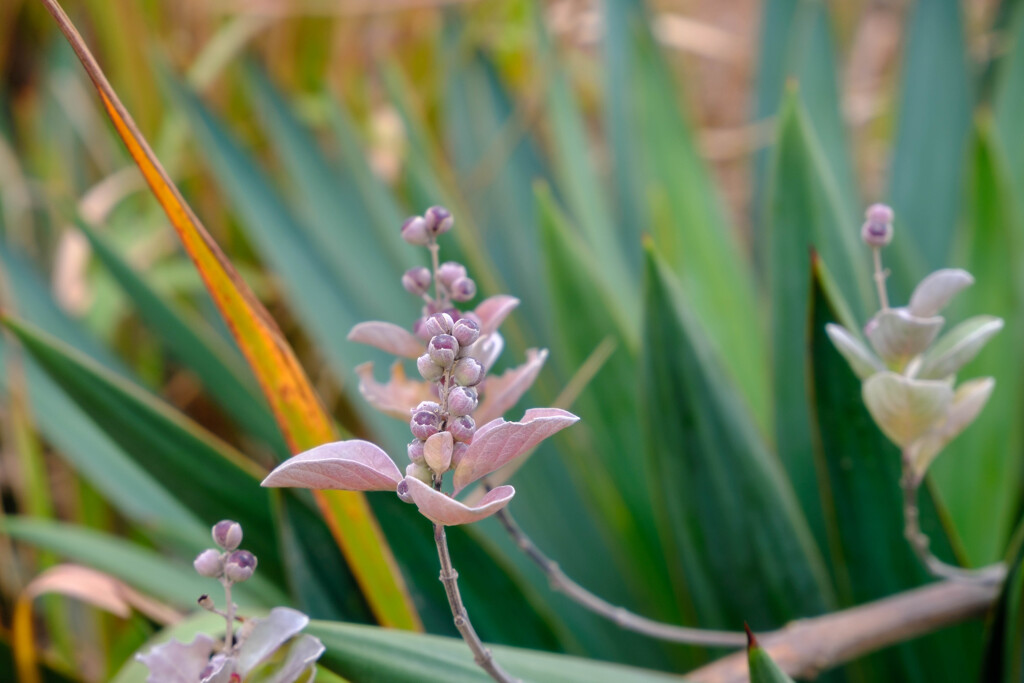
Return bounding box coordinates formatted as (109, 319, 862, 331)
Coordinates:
(932, 121, 1024, 564)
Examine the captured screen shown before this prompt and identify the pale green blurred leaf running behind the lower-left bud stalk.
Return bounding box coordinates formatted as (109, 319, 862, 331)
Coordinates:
(0, 517, 288, 610)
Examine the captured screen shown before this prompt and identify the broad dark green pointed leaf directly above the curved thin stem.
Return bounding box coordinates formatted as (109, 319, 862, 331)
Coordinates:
(641, 242, 831, 628)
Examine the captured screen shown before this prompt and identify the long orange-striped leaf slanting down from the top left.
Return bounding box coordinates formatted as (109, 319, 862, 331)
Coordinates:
(41, 0, 422, 630)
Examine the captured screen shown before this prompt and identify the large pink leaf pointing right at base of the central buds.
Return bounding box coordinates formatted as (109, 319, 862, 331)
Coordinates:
(454, 408, 580, 494)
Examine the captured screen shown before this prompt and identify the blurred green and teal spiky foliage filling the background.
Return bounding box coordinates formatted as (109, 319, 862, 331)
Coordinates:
(0, 0, 1024, 683)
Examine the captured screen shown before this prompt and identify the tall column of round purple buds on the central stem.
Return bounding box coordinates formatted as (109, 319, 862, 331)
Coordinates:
(401, 207, 486, 484)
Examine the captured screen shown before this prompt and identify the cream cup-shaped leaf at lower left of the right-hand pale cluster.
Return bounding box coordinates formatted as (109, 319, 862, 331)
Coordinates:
(863, 372, 953, 449)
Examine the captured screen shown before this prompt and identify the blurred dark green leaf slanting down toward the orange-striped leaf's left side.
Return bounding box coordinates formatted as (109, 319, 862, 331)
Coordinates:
(78, 220, 288, 454)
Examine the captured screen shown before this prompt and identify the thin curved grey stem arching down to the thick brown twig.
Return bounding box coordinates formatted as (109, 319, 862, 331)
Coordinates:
(495, 510, 746, 647)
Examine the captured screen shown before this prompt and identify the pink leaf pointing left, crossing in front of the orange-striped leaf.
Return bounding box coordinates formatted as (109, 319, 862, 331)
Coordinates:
(262, 439, 401, 490)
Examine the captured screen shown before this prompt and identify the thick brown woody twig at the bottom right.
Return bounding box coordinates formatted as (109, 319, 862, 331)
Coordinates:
(686, 581, 1000, 683)
